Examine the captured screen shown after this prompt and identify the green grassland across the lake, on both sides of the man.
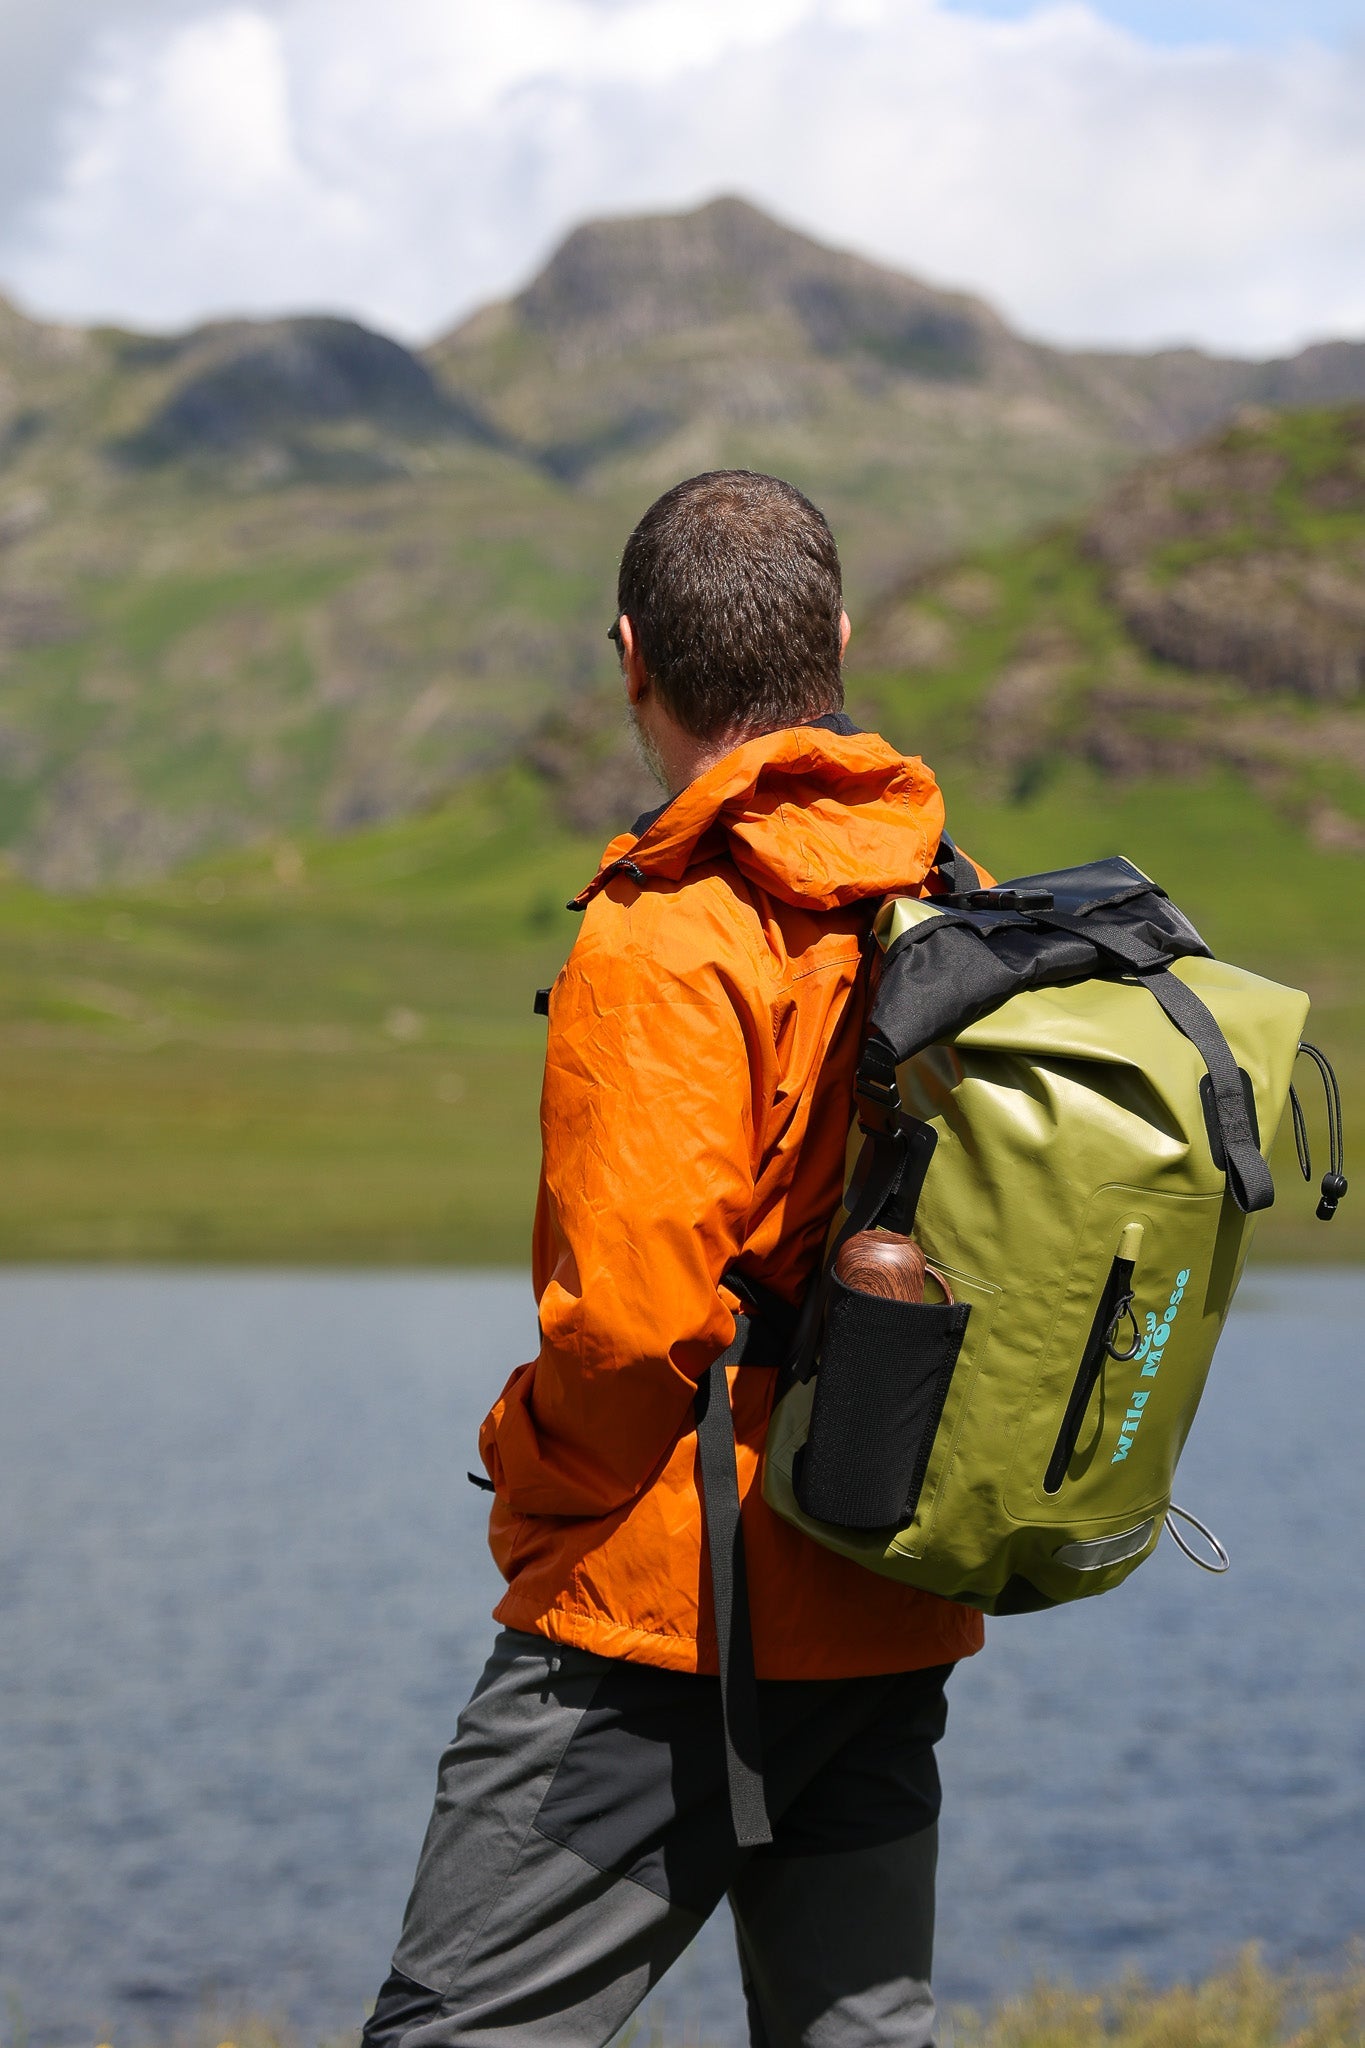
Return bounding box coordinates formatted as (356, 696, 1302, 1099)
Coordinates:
(0, 729, 1365, 1264)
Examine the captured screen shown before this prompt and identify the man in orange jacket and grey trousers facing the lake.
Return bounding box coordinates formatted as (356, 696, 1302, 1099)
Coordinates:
(366, 471, 980, 2048)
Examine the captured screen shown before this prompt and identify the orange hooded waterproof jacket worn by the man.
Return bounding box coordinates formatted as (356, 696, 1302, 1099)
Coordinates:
(479, 727, 982, 1677)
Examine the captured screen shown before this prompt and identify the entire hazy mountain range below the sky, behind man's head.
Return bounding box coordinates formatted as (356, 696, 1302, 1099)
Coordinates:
(0, 199, 1365, 889)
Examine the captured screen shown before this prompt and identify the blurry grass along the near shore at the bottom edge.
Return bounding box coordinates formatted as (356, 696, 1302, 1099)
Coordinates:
(34, 1942, 1365, 2048)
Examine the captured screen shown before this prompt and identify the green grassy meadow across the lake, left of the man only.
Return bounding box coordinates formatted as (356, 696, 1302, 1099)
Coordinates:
(0, 776, 589, 1264)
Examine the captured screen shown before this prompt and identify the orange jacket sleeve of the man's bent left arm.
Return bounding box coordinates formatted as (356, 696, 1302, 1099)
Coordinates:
(479, 885, 774, 1516)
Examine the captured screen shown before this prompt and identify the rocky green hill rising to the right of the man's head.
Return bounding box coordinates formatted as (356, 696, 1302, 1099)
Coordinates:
(849, 406, 1365, 852)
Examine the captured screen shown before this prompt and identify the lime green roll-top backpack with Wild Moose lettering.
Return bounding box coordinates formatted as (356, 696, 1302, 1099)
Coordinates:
(763, 858, 1345, 1614)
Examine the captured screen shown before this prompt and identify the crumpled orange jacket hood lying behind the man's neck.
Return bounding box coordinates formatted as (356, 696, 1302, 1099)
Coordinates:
(573, 725, 943, 909)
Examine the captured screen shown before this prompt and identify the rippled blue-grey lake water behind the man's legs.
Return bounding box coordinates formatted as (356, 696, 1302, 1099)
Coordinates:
(0, 1272, 1365, 2044)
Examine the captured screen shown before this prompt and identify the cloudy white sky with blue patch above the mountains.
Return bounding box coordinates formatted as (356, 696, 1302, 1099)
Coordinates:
(0, 0, 1365, 354)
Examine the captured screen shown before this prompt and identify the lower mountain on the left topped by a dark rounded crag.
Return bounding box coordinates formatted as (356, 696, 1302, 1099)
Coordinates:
(0, 299, 616, 889)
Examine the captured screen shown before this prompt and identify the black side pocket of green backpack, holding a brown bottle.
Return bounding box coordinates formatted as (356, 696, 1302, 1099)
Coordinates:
(792, 1274, 972, 1530)
